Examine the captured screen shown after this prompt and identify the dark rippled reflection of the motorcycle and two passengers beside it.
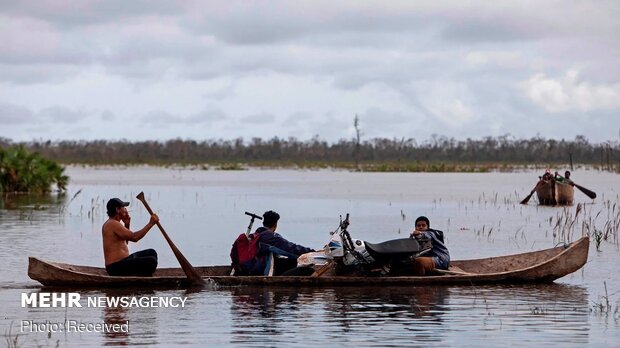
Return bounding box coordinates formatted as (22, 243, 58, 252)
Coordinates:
(225, 287, 450, 345)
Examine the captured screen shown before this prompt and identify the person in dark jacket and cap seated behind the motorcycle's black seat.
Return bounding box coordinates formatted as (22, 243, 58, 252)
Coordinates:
(410, 216, 450, 275)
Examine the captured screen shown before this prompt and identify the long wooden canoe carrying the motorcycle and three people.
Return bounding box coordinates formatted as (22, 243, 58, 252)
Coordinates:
(28, 237, 590, 288)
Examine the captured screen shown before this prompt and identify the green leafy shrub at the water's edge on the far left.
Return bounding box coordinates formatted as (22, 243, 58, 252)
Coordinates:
(0, 146, 69, 193)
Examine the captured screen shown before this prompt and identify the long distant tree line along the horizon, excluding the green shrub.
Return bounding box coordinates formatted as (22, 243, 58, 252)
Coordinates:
(0, 135, 620, 170)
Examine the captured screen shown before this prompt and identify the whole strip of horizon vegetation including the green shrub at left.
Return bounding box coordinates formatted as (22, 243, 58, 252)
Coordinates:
(0, 135, 620, 193)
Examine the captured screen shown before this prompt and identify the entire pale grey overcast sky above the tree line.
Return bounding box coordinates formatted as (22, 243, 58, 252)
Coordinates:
(0, 0, 620, 143)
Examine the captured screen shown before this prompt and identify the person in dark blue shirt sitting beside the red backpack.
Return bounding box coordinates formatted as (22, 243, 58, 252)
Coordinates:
(253, 210, 315, 275)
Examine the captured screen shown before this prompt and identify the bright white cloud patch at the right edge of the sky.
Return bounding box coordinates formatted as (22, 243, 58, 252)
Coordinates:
(521, 70, 620, 113)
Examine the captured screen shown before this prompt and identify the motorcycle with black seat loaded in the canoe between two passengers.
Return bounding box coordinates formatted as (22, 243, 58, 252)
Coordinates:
(297, 213, 431, 276)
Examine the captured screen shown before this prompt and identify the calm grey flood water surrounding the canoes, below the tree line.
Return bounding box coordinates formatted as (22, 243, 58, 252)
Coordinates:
(0, 167, 620, 347)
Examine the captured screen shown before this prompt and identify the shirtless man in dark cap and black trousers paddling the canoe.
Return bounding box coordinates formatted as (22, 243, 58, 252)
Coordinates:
(101, 198, 159, 277)
